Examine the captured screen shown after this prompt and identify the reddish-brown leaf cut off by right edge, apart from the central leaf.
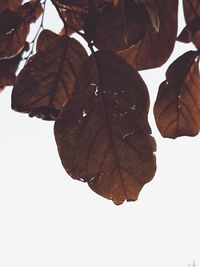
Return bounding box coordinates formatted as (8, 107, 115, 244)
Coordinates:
(154, 51, 200, 138)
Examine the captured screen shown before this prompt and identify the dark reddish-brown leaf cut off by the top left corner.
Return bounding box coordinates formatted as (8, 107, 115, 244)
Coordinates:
(0, 1, 42, 59)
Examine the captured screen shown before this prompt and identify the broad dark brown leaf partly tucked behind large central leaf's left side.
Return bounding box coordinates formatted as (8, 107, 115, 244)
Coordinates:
(12, 31, 87, 120)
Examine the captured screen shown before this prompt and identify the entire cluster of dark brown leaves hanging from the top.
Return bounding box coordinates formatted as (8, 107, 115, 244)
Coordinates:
(0, 0, 200, 204)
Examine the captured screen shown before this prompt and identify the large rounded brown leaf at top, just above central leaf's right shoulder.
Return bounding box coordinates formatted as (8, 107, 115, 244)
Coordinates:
(119, 0, 178, 70)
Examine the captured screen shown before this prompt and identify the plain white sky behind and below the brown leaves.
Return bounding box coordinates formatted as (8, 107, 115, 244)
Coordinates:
(0, 1, 200, 267)
